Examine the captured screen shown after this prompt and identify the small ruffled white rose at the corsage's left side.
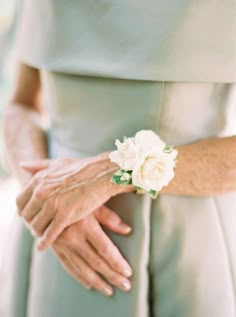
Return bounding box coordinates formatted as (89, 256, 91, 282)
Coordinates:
(109, 138, 140, 171)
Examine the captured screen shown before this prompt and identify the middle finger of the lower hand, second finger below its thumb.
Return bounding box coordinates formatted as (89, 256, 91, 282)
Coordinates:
(79, 239, 131, 292)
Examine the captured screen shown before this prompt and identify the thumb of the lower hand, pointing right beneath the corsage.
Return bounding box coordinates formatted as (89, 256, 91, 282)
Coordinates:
(94, 205, 132, 234)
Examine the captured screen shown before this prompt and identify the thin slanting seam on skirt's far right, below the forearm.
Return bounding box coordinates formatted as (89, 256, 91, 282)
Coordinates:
(213, 197, 236, 317)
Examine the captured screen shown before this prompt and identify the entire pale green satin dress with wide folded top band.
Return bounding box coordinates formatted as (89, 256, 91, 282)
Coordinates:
(0, 0, 236, 317)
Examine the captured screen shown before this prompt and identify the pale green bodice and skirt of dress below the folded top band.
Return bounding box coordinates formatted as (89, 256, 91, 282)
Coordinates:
(0, 70, 236, 317)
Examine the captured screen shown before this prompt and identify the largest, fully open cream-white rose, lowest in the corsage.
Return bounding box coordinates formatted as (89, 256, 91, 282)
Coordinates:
(132, 152, 175, 192)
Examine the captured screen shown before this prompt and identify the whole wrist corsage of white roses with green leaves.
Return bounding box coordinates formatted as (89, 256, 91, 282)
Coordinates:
(109, 130, 178, 198)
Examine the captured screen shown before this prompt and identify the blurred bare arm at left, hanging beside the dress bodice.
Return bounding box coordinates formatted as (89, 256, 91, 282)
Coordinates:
(4, 64, 47, 184)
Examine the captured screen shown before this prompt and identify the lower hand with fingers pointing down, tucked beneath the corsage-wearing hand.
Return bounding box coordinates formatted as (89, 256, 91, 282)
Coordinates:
(52, 206, 132, 296)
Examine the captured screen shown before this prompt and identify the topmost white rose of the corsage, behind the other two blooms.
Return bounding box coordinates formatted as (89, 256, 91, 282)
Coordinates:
(134, 130, 166, 154)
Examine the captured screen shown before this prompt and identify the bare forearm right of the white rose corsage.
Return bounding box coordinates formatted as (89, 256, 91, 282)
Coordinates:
(161, 136, 236, 196)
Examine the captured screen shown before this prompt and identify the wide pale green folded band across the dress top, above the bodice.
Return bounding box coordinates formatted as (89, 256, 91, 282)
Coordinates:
(16, 0, 236, 82)
